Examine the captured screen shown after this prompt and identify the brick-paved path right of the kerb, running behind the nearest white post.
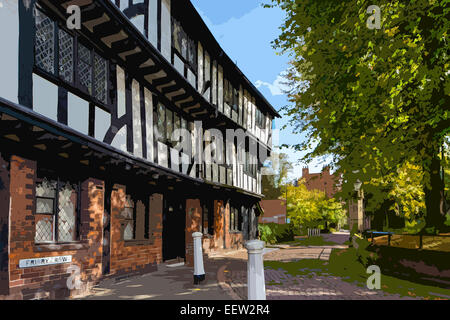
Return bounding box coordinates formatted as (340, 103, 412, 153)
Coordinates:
(217, 232, 413, 300)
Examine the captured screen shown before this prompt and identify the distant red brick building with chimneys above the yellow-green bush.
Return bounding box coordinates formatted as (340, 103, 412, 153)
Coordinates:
(302, 167, 339, 198)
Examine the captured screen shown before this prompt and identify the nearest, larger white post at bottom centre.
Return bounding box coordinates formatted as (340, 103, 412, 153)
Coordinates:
(245, 240, 266, 300)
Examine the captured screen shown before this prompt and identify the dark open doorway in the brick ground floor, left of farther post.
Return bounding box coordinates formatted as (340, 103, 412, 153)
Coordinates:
(163, 197, 186, 261)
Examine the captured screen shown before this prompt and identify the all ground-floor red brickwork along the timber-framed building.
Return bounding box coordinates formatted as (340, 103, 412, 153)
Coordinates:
(0, 155, 250, 300)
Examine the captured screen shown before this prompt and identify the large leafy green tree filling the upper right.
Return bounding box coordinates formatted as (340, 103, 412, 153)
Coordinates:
(271, 0, 450, 232)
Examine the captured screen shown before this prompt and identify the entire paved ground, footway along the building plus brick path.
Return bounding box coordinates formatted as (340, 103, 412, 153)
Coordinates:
(78, 232, 422, 300)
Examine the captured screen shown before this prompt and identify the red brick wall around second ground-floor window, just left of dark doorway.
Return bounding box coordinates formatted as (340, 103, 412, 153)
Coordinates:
(110, 185, 163, 274)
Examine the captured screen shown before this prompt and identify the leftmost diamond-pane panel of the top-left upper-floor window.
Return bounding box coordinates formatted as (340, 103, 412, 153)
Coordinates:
(34, 10, 55, 74)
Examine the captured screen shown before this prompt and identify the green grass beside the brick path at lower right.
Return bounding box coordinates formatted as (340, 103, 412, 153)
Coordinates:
(264, 248, 450, 299)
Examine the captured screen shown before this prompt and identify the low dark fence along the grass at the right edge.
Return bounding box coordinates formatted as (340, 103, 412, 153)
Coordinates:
(367, 231, 450, 252)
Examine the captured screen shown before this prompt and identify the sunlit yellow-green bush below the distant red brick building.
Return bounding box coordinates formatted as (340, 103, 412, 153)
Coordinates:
(287, 181, 346, 230)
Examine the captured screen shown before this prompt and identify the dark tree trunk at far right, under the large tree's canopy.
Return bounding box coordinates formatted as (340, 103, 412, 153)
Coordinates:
(424, 153, 445, 232)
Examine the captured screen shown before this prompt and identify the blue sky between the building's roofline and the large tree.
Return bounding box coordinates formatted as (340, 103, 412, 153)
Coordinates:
(191, 0, 324, 179)
